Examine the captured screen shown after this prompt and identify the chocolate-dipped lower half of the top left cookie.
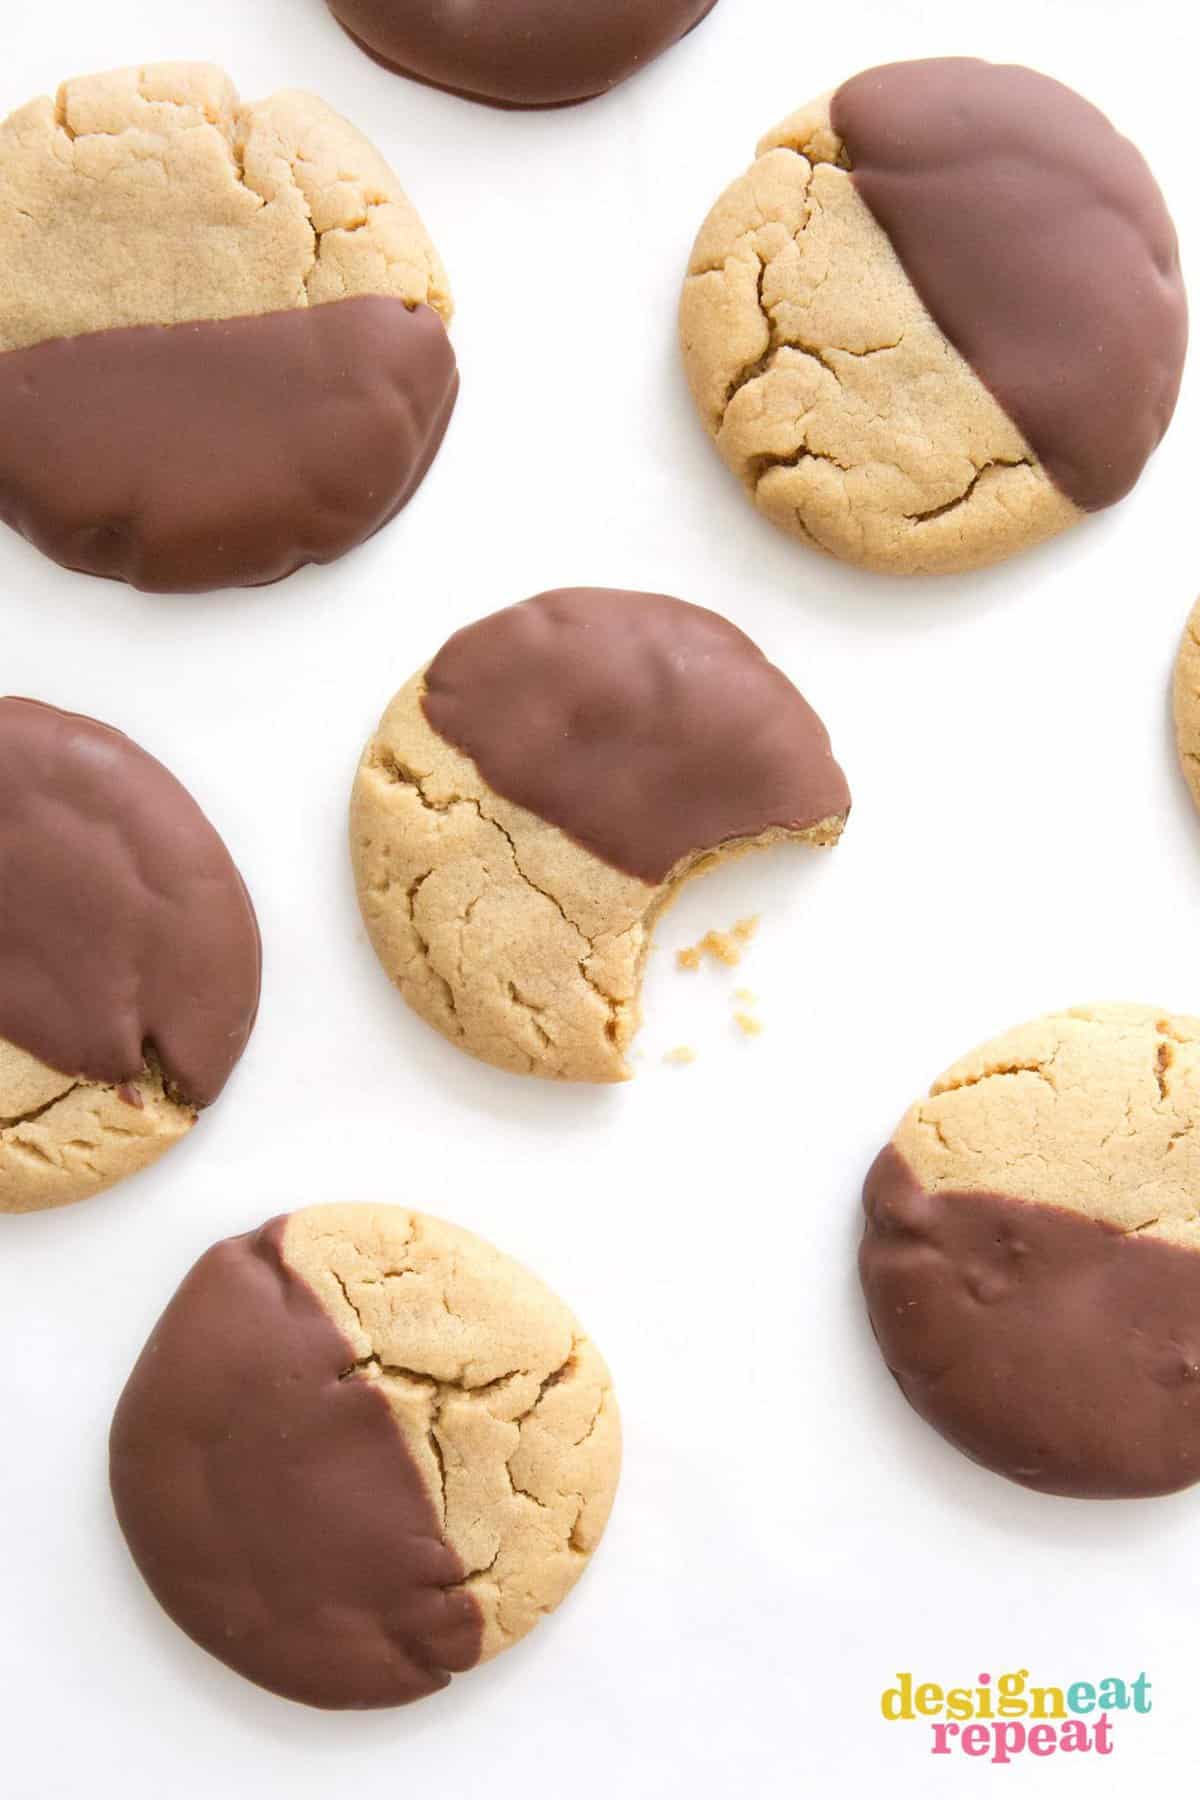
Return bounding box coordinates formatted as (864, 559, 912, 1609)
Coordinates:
(0, 295, 459, 594)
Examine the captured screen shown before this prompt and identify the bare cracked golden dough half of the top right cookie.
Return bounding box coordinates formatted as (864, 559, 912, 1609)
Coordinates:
(680, 101, 1081, 572)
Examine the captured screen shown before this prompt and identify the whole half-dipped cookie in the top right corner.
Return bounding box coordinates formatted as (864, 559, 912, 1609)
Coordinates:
(680, 58, 1187, 574)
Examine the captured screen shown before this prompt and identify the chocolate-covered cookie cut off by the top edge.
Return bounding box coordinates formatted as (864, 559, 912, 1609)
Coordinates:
(329, 0, 716, 106)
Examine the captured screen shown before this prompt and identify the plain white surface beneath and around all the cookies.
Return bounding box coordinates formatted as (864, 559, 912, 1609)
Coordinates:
(0, 0, 1200, 1800)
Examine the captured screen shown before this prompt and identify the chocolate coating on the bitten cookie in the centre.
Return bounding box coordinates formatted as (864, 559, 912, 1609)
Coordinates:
(423, 587, 849, 884)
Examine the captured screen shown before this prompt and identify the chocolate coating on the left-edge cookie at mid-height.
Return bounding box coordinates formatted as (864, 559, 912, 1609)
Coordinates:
(0, 700, 261, 1105)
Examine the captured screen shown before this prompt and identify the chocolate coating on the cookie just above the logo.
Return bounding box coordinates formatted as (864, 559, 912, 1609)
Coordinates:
(858, 1145, 1200, 1499)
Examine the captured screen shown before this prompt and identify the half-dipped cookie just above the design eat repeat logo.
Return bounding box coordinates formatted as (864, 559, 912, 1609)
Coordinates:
(860, 1006, 1200, 1498)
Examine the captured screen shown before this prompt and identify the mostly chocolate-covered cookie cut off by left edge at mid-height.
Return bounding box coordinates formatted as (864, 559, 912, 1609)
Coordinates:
(0, 700, 261, 1213)
